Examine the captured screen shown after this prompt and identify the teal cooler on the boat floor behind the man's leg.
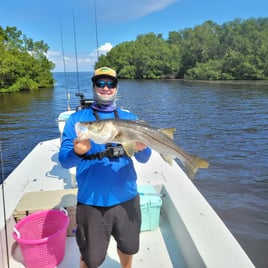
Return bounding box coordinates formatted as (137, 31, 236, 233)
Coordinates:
(138, 185, 162, 232)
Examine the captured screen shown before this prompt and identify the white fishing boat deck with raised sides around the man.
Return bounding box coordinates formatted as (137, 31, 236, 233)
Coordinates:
(0, 139, 254, 268)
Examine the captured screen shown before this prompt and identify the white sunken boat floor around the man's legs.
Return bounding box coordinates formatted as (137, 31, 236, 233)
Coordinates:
(59, 213, 185, 268)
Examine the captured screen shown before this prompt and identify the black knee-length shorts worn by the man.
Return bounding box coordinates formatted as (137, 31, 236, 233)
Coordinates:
(76, 195, 141, 268)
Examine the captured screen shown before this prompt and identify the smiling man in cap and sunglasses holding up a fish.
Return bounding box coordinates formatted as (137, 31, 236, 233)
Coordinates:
(59, 67, 151, 268)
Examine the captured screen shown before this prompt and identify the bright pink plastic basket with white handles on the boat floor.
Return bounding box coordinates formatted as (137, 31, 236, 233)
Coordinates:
(13, 210, 69, 268)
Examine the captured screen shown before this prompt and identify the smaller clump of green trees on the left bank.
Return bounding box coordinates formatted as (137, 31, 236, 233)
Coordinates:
(0, 27, 54, 93)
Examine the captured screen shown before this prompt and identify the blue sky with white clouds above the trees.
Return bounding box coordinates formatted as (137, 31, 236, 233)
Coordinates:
(0, 0, 268, 71)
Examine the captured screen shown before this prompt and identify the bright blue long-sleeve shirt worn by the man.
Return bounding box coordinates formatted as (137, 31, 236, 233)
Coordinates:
(59, 108, 151, 207)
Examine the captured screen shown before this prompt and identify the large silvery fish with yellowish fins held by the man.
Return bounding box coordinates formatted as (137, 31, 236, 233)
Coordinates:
(75, 119, 209, 179)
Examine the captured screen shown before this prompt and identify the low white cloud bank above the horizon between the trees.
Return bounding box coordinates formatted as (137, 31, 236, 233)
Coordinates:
(47, 43, 113, 72)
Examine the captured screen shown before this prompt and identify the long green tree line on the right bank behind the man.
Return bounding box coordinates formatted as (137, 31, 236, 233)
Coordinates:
(95, 18, 268, 80)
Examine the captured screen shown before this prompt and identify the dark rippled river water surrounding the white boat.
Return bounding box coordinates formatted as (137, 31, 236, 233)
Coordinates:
(0, 73, 268, 267)
